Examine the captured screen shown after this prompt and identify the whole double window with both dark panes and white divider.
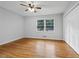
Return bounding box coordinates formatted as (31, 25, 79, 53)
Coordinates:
(37, 20, 54, 31)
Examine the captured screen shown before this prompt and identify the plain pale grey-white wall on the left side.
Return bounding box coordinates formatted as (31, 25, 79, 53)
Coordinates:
(0, 8, 24, 44)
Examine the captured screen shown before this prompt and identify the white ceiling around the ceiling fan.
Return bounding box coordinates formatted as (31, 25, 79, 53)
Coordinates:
(0, 1, 71, 16)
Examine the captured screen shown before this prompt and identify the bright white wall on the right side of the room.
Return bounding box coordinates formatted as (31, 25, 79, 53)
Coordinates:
(63, 4, 79, 54)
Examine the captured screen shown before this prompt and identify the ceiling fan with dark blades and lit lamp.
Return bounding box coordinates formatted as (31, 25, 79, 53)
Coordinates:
(20, 1, 41, 13)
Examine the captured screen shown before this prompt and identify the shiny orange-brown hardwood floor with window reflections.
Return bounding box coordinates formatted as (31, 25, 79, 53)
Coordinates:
(0, 38, 79, 58)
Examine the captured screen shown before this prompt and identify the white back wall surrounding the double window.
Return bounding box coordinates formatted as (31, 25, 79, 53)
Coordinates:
(25, 14, 63, 40)
